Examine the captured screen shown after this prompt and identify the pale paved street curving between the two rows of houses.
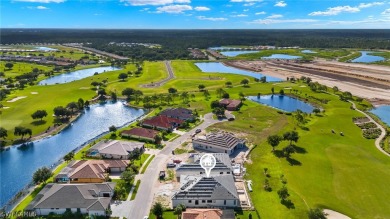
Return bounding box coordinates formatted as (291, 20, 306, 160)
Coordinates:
(127, 113, 226, 219)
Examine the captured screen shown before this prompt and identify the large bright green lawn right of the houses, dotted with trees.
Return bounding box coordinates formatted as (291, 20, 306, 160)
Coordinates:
(214, 86, 390, 218)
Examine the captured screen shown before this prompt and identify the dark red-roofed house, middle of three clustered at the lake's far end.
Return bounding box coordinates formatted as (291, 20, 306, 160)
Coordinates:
(142, 115, 184, 131)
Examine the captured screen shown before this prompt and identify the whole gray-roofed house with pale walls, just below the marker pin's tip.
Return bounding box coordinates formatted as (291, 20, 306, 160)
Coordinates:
(172, 175, 240, 208)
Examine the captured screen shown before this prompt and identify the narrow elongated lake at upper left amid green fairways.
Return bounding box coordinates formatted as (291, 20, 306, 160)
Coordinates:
(39, 66, 121, 85)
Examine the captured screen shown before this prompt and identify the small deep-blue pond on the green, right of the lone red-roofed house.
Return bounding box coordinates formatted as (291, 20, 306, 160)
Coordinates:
(248, 95, 314, 113)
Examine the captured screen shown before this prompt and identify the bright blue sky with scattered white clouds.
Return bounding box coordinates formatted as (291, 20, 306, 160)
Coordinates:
(0, 0, 390, 29)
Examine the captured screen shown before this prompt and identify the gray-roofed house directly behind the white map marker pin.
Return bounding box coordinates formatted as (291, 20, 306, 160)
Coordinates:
(176, 153, 233, 181)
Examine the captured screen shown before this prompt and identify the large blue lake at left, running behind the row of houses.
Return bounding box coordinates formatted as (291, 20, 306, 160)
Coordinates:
(0, 102, 145, 207)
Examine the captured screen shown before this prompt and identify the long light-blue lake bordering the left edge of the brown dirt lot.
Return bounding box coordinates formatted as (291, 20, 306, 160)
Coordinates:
(195, 62, 283, 81)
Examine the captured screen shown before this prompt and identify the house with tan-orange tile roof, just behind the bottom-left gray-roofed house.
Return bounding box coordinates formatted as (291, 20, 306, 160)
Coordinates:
(55, 160, 130, 183)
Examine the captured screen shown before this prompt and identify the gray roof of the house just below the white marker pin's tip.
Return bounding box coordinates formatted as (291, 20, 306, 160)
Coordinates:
(173, 175, 238, 200)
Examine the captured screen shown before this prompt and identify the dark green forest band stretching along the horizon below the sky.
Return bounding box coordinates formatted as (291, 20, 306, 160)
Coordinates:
(0, 29, 390, 60)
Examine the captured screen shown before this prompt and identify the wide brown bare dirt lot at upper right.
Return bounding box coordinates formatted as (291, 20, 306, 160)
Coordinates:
(225, 60, 390, 102)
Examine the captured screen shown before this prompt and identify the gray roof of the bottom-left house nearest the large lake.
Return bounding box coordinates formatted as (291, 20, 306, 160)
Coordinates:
(26, 183, 115, 210)
